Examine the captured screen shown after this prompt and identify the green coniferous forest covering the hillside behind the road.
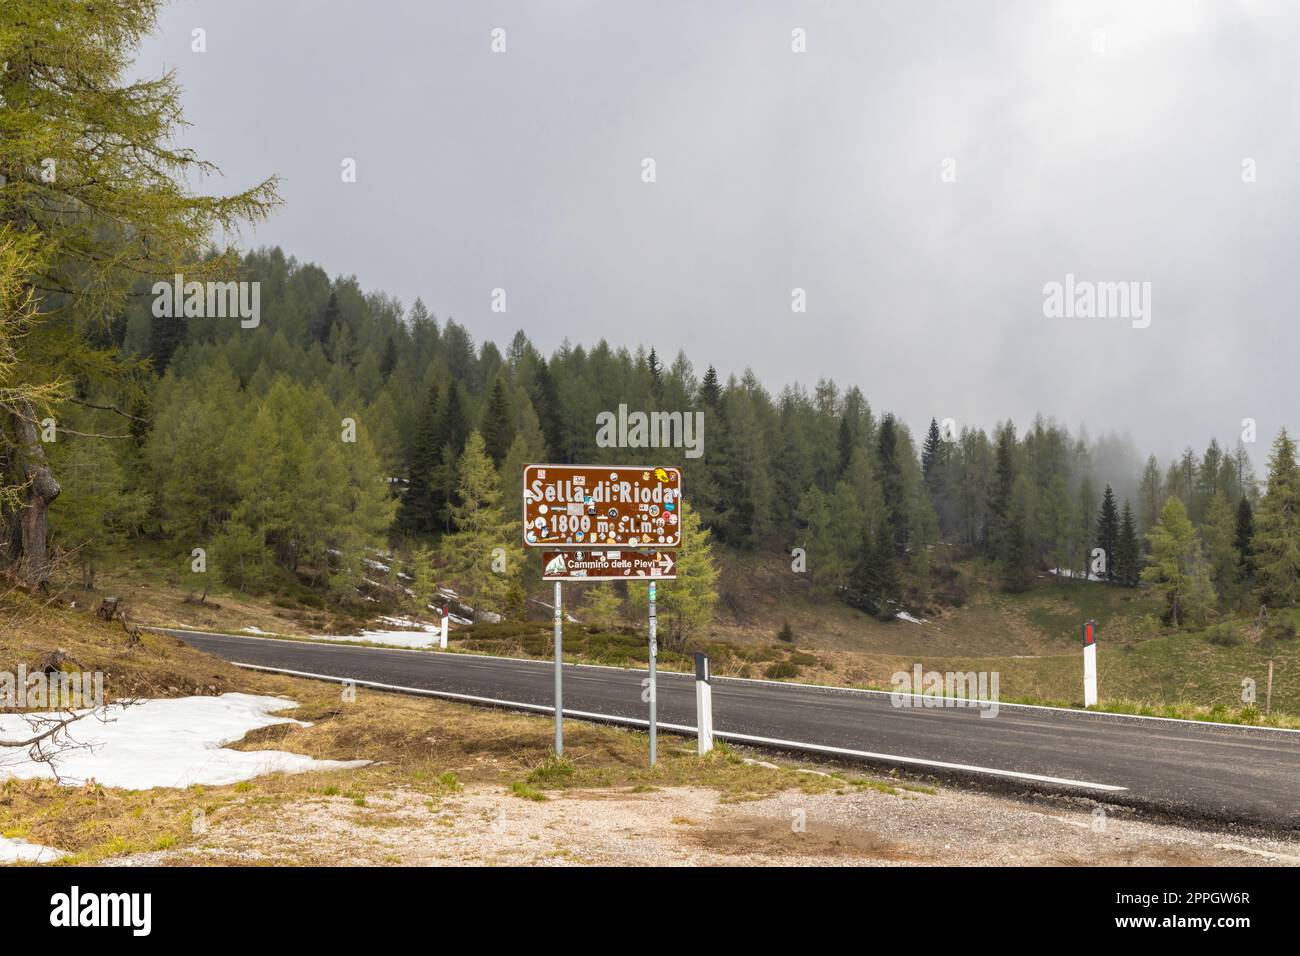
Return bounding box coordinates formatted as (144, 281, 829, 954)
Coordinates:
(12, 248, 1300, 639)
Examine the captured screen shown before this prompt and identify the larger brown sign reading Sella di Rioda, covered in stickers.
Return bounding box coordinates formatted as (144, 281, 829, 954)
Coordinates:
(524, 464, 681, 550)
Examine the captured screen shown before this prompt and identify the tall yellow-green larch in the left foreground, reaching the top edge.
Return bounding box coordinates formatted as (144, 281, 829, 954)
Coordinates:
(0, 0, 278, 584)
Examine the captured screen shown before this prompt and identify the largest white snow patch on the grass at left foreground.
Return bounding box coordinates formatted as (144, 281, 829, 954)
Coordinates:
(0, 693, 369, 790)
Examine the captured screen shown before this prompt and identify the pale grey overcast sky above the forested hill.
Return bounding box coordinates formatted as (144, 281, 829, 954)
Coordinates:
(138, 0, 1300, 466)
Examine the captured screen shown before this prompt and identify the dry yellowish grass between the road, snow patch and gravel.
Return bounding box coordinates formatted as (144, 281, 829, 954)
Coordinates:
(0, 656, 873, 864)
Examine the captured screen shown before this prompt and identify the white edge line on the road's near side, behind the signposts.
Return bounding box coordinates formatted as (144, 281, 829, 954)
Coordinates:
(230, 661, 1128, 792)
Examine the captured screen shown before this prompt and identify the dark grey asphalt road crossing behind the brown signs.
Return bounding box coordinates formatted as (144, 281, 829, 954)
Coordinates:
(169, 631, 1300, 829)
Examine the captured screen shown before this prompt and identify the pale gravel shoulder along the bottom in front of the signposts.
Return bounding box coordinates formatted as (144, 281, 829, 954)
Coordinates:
(114, 786, 1300, 866)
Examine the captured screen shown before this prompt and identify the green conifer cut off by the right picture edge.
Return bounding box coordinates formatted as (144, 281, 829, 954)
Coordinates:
(1252, 428, 1300, 607)
